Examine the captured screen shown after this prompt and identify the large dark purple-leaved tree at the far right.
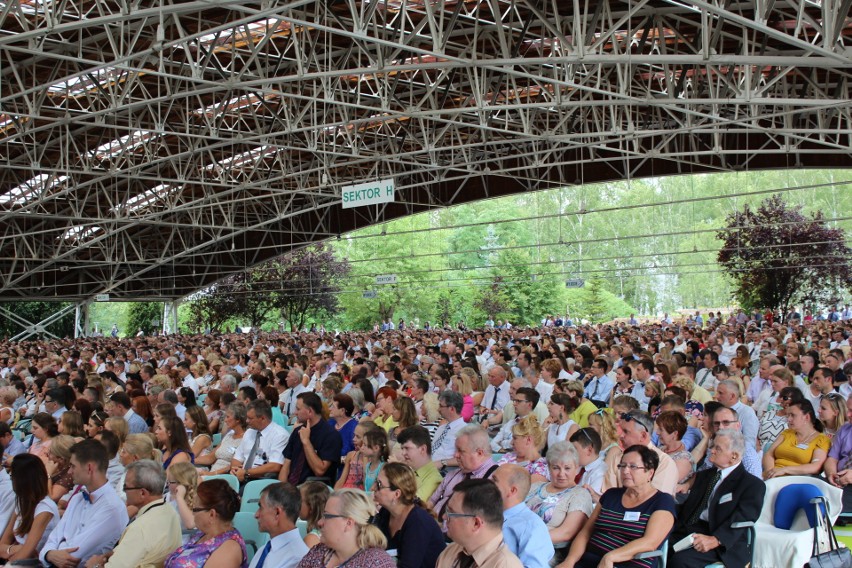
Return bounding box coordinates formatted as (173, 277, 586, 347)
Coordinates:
(717, 196, 852, 313)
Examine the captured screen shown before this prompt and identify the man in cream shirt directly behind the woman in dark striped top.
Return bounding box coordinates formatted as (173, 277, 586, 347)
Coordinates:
(603, 410, 678, 496)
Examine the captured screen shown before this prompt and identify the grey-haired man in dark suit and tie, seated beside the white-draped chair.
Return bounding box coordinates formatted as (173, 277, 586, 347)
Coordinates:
(666, 429, 766, 568)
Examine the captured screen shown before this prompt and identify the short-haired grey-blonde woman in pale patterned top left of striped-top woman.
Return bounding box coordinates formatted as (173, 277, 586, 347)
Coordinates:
(526, 441, 594, 556)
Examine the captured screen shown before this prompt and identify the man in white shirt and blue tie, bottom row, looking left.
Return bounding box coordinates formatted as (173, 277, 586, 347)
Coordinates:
(249, 482, 308, 568)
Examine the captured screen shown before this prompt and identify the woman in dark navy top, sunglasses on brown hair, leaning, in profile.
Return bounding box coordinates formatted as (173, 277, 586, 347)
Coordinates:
(373, 463, 446, 568)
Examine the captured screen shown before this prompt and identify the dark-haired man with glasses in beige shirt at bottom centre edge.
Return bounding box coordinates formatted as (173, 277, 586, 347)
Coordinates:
(436, 479, 523, 568)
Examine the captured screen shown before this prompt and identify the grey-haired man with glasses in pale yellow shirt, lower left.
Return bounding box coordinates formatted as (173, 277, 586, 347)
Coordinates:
(86, 460, 181, 568)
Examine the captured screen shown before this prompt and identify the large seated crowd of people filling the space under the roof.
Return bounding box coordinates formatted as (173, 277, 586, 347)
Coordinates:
(0, 308, 852, 568)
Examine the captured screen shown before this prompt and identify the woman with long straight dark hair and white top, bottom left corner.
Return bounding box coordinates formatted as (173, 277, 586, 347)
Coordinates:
(0, 454, 59, 564)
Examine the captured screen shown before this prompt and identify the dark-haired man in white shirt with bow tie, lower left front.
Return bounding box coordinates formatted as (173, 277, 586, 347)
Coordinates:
(39, 439, 128, 568)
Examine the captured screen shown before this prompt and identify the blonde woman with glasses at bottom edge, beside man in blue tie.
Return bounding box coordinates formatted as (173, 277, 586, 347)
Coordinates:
(296, 489, 396, 568)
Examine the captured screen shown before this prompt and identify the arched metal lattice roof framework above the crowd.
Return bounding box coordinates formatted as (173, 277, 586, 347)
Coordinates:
(0, 0, 852, 302)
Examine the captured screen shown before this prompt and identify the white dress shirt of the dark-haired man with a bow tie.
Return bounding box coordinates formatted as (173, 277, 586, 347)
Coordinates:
(39, 483, 129, 565)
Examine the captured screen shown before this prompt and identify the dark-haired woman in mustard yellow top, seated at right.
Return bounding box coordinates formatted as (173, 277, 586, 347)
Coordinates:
(763, 400, 831, 479)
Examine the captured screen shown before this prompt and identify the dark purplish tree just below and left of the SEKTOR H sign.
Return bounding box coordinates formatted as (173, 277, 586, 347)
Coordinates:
(271, 243, 350, 331)
